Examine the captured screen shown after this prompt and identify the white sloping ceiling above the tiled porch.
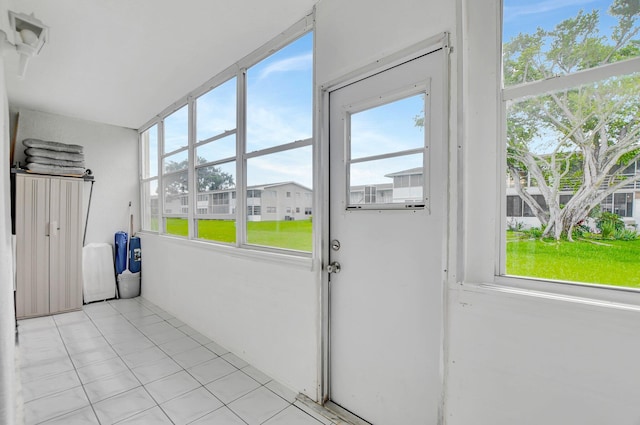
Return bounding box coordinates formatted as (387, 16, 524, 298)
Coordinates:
(5, 0, 318, 128)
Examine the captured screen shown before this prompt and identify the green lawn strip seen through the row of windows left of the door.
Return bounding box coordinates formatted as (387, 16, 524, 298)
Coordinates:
(167, 218, 312, 252)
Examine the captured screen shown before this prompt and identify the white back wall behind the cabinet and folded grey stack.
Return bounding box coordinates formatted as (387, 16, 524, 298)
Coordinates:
(15, 109, 140, 244)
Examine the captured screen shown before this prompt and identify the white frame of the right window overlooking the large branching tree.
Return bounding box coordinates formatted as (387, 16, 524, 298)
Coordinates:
(498, 0, 640, 300)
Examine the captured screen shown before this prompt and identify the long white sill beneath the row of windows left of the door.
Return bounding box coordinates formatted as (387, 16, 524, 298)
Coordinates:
(136, 231, 317, 271)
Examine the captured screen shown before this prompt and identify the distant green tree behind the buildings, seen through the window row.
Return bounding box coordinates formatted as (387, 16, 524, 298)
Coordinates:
(165, 157, 235, 195)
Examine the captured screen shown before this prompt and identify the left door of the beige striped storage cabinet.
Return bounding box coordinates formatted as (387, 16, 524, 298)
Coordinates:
(15, 175, 50, 318)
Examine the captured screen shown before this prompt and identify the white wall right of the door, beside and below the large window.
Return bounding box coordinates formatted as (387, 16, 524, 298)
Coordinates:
(445, 0, 640, 425)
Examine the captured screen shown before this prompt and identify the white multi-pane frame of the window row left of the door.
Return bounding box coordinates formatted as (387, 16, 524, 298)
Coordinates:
(138, 9, 319, 265)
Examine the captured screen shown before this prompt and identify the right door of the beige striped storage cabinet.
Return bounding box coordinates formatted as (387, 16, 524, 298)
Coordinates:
(49, 178, 82, 313)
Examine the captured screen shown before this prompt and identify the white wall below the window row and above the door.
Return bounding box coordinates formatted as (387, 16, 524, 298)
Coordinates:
(142, 0, 455, 399)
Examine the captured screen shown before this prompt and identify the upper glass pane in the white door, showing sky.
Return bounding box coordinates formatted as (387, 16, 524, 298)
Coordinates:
(351, 94, 424, 159)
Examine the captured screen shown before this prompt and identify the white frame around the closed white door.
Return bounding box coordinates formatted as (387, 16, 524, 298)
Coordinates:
(314, 32, 450, 416)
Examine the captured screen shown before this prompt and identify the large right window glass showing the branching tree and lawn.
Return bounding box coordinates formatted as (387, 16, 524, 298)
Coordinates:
(500, 0, 640, 287)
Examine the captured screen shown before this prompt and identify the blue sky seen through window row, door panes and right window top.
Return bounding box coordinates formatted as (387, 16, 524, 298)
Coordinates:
(155, 0, 632, 195)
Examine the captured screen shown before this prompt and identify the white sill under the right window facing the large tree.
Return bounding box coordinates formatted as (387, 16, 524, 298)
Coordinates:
(462, 276, 640, 311)
